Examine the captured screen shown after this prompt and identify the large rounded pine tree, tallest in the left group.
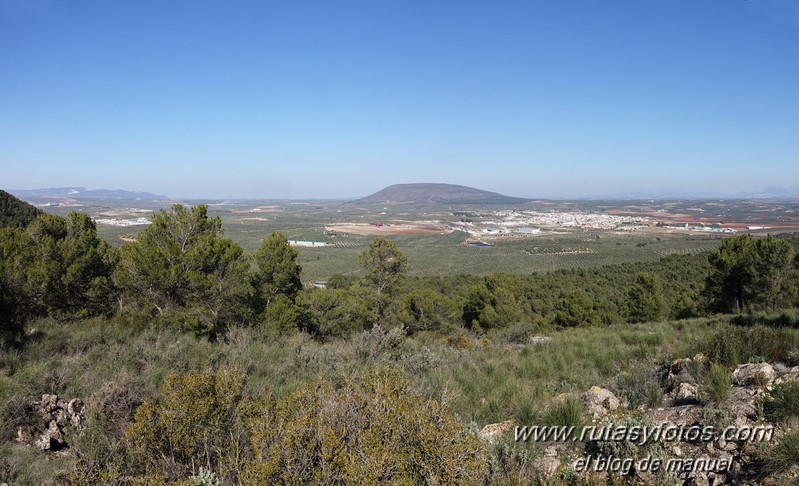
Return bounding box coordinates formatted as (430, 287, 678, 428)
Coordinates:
(114, 204, 252, 337)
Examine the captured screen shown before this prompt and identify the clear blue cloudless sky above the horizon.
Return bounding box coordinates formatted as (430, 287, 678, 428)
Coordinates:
(0, 0, 799, 198)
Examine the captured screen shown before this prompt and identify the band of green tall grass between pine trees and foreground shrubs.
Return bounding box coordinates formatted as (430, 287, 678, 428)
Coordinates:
(0, 319, 799, 484)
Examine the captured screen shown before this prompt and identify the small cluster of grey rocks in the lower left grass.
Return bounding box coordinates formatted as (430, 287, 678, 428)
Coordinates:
(17, 394, 86, 451)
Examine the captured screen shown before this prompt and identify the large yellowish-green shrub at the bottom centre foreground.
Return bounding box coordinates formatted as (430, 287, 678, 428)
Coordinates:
(243, 369, 489, 484)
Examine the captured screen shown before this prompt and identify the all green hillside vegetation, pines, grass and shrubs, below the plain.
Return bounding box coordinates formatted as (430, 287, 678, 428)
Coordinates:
(0, 205, 799, 484)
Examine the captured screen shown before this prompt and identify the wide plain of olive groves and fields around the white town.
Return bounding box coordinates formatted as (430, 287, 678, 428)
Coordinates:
(34, 196, 799, 284)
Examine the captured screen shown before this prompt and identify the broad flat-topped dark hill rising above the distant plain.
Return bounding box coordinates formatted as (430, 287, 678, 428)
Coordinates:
(354, 183, 530, 204)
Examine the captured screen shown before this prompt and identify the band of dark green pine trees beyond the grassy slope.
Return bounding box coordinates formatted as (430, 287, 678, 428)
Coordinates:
(0, 204, 799, 339)
